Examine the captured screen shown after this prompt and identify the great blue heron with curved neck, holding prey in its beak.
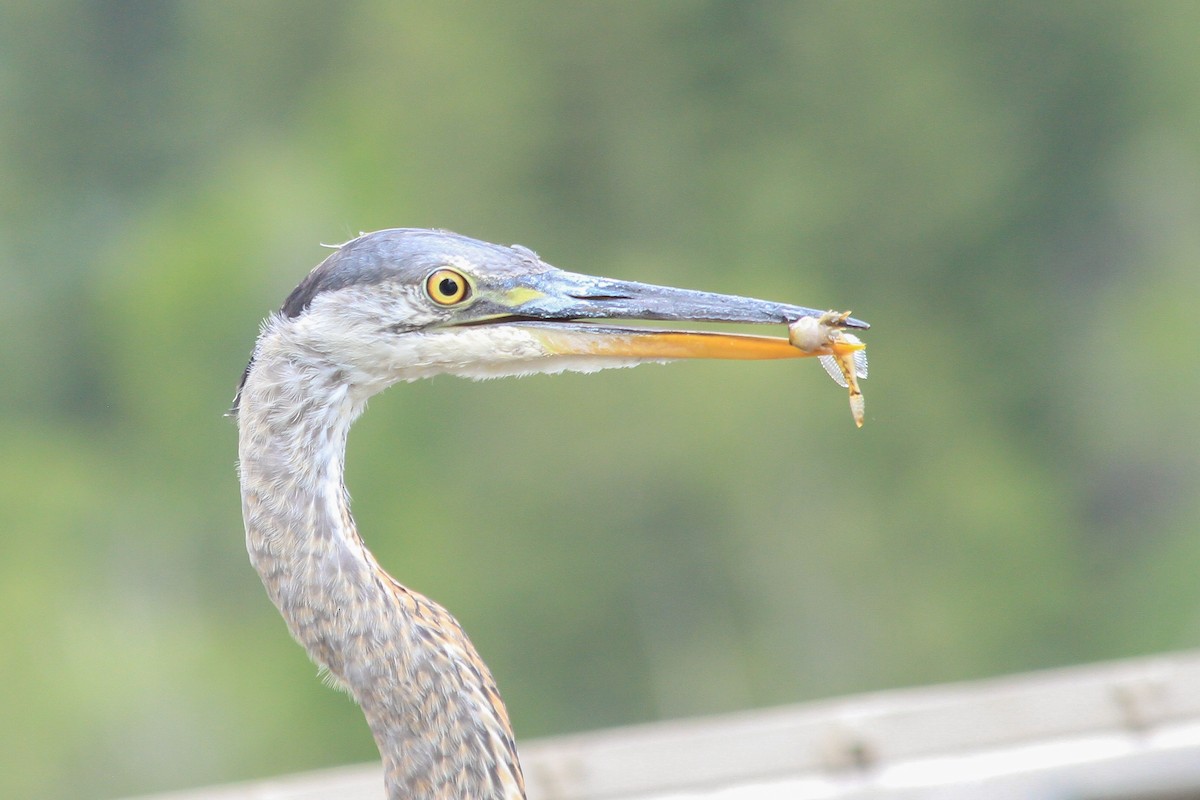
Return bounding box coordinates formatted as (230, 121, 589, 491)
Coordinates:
(234, 229, 866, 800)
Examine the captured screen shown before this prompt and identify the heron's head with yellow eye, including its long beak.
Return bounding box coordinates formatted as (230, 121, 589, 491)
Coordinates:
(235, 229, 866, 407)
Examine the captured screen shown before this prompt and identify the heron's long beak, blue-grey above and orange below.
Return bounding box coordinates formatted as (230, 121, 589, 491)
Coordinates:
(480, 269, 869, 360)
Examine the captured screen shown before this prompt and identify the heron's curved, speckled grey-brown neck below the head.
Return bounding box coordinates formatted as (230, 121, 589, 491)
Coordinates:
(238, 348, 524, 800)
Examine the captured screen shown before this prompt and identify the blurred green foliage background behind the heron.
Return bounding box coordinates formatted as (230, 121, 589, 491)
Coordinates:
(0, 0, 1200, 798)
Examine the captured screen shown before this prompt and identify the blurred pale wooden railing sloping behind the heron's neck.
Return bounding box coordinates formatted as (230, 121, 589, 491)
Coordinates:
(121, 651, 1200, 800)
